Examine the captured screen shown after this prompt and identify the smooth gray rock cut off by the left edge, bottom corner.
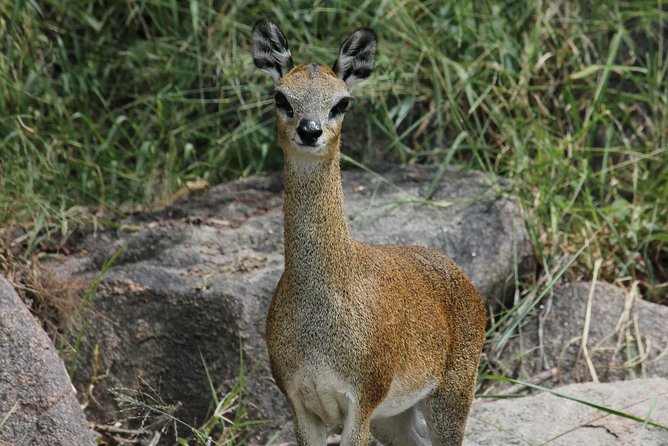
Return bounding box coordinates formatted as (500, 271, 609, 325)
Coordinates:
(0, 277, 96, 446)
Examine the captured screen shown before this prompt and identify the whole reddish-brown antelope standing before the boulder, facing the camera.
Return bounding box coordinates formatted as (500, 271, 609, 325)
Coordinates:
(253, 21, 485, 446)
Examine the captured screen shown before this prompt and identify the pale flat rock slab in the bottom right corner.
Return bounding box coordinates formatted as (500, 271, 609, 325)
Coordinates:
(464, 378, 668, 446)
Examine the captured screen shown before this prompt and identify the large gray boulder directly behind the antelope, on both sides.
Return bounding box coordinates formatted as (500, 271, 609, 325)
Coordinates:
(51, 166, 532, 438)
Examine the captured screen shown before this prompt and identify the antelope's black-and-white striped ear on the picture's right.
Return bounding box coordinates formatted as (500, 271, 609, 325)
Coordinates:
(332, 28, 376, 88)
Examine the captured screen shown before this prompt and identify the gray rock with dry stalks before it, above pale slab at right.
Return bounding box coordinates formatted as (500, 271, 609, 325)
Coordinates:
(503, 282, 668, 383)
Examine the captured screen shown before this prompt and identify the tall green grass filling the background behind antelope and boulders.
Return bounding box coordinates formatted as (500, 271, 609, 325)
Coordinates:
(0, 0, 668, 442)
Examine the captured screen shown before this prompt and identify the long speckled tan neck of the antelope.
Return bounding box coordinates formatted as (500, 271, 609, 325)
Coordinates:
(283, 156, 355, 286)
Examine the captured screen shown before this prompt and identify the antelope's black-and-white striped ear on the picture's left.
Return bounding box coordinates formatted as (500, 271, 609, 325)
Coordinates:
(253, 20, 293, 81)
